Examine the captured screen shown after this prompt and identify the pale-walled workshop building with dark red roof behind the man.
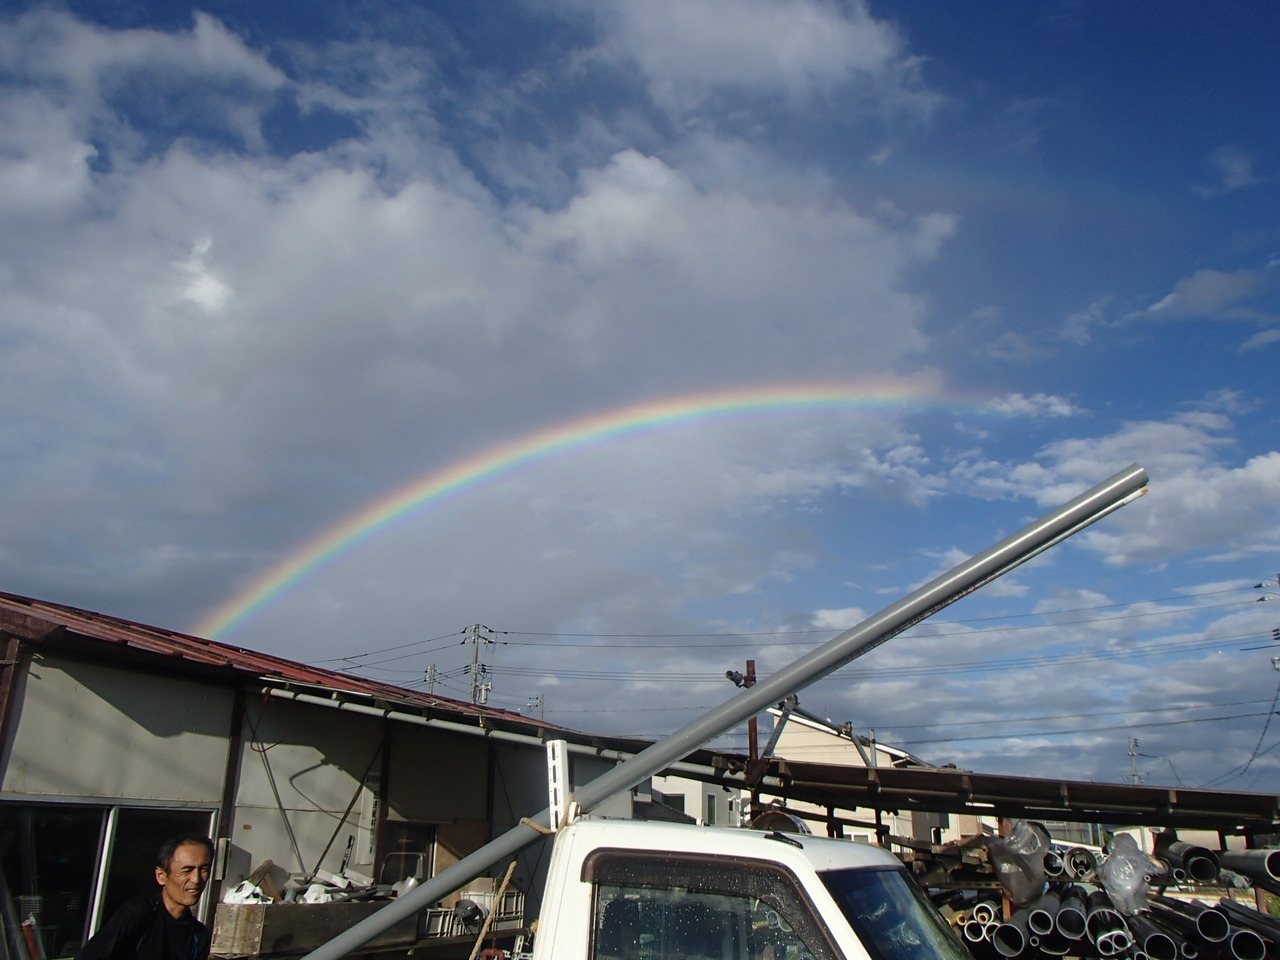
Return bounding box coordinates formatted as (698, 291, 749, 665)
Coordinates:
(0, 594, 721, 957)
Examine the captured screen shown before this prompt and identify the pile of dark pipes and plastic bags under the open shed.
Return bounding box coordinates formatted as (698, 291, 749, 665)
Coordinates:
(940, 822, 1280, 960)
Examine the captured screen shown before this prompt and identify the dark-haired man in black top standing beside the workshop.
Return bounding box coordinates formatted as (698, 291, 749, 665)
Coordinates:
(77, 836, 214, 960)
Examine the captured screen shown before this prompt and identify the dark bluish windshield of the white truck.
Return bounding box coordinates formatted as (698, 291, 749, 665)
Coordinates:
(820, 867, 972, 960)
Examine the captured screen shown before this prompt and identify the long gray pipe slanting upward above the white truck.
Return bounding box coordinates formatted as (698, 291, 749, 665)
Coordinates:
(303, 463, 1147, 960)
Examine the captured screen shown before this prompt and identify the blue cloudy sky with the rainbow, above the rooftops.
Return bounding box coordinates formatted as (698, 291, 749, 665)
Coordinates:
(0, 0, 1280, 792)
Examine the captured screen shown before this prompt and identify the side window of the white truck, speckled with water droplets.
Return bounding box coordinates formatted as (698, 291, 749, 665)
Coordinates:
(584, 850, 838, 960)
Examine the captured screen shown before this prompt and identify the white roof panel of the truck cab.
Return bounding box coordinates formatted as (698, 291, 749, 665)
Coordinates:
(567, 818, 902, 870)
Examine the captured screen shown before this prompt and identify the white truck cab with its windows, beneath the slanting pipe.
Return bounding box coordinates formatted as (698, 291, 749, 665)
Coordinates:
(534, 819, 970, 960)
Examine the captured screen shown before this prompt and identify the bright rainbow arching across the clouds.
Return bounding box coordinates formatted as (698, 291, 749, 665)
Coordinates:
(191, 379, 972, 639)
